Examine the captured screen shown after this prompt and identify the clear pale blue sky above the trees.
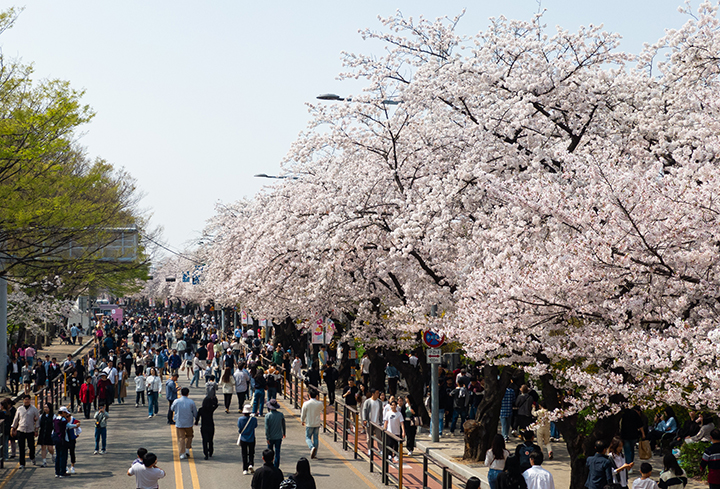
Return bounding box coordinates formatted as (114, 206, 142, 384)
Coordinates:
(0, 0, 698, 255)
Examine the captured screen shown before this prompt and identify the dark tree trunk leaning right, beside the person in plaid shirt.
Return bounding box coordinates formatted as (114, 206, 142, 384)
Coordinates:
(463, 365, 516, 461)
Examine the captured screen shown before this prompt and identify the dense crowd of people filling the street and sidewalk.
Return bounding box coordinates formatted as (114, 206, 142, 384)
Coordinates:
(0, 311, 720, 489)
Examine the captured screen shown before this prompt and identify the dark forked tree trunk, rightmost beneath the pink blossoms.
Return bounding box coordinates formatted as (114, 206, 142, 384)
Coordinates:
(542, 375, 620, 489)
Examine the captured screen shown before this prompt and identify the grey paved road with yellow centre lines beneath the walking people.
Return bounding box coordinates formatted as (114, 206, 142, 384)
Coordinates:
(0, 382, 385, 489)
